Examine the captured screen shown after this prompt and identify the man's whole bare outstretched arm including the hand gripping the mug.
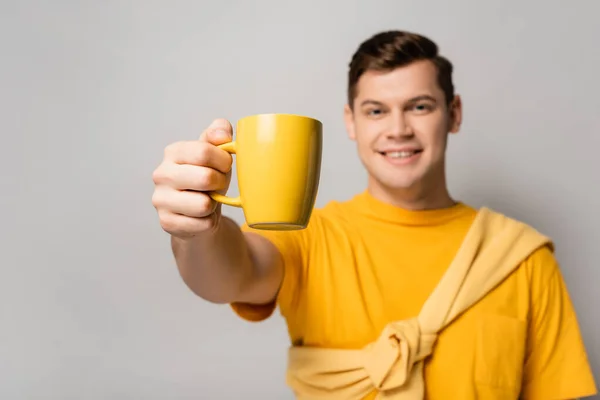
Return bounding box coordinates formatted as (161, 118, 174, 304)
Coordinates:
(152, 119, 283, 304)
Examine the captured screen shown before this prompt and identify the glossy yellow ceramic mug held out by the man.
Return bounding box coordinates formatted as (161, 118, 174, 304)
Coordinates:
(209, 114, 323, 230)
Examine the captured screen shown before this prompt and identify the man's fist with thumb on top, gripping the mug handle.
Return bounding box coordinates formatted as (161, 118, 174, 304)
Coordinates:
(152, 119, 233, 238)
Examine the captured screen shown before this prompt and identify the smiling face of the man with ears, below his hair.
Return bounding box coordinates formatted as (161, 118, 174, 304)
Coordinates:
(345, 60, 462, 206)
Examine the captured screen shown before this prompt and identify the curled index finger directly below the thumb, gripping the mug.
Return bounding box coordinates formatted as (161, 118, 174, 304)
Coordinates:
(165, 140, 233, 173)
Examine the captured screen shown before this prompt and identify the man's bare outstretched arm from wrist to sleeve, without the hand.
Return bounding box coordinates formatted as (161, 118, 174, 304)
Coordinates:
(171, 217, 283, 304)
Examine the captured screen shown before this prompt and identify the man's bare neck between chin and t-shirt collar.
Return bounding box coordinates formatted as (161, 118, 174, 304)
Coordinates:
(368, 179, 456, 211)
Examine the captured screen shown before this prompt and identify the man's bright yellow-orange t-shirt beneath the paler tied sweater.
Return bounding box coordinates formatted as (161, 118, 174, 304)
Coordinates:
(232, 191, 596, 400)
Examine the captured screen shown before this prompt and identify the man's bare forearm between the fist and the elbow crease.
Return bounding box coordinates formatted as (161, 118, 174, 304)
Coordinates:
(171, 216, 253, 303)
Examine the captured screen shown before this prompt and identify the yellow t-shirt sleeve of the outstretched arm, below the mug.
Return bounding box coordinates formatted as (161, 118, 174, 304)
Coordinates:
(230, 220, 315, 322)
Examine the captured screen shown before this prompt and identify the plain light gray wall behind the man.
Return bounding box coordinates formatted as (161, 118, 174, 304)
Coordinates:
(0, 0, 600, 399)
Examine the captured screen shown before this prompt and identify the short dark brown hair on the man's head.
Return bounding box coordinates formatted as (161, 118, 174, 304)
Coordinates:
(348, 31, 454, 108)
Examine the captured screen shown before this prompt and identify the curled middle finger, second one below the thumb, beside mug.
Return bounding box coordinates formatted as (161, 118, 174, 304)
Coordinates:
(155, 164, 228, 192)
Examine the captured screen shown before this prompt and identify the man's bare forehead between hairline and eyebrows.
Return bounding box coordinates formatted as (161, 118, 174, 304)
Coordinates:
(356, 60, 444, 101)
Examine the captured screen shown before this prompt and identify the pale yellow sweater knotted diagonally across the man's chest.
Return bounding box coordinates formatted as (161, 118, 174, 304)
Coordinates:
(287, 208, 552, 400)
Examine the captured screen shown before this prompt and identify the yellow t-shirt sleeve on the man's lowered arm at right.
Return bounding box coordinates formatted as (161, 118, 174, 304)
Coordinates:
(522, 248, 597, 400)
